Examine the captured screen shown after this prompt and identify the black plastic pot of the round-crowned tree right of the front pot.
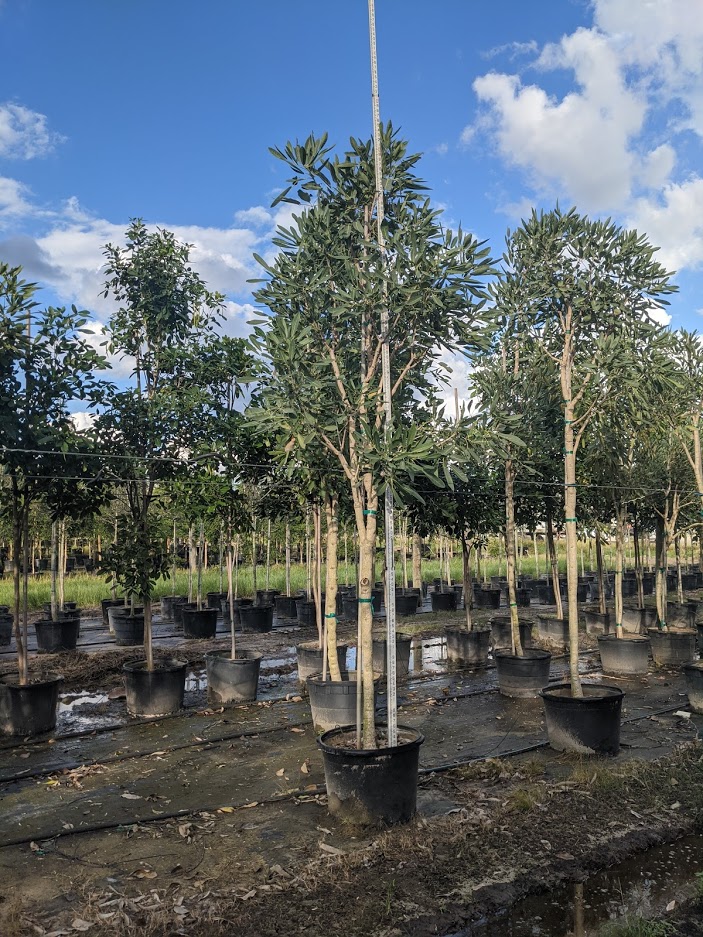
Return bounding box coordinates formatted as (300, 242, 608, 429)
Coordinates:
(539, 683, 625, 755)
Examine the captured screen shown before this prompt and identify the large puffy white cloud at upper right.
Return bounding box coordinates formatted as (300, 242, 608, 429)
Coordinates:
(462, 0, 703, 270)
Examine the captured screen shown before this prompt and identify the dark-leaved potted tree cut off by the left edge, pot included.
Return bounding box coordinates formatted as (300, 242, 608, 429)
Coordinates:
(0, 264, 110, 735)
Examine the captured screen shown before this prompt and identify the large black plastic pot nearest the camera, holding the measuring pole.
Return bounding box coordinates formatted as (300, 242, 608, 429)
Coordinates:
(317, 726, 425, 826)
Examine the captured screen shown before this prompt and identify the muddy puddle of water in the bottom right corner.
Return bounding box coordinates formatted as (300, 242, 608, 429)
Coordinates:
(464, 834, 703, 937)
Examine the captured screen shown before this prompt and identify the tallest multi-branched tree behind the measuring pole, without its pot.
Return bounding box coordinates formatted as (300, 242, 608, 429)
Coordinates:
(254, 125, 491, 748)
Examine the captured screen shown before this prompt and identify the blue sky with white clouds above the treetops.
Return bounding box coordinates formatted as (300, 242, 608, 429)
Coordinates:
(0, 0, 703, 390)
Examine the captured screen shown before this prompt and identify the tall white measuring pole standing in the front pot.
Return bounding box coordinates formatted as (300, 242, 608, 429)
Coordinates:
(368, 0, 398, 747)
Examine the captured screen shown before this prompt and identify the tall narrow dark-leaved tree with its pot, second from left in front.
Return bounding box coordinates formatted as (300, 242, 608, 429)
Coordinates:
(97, 219, 223, 716)
